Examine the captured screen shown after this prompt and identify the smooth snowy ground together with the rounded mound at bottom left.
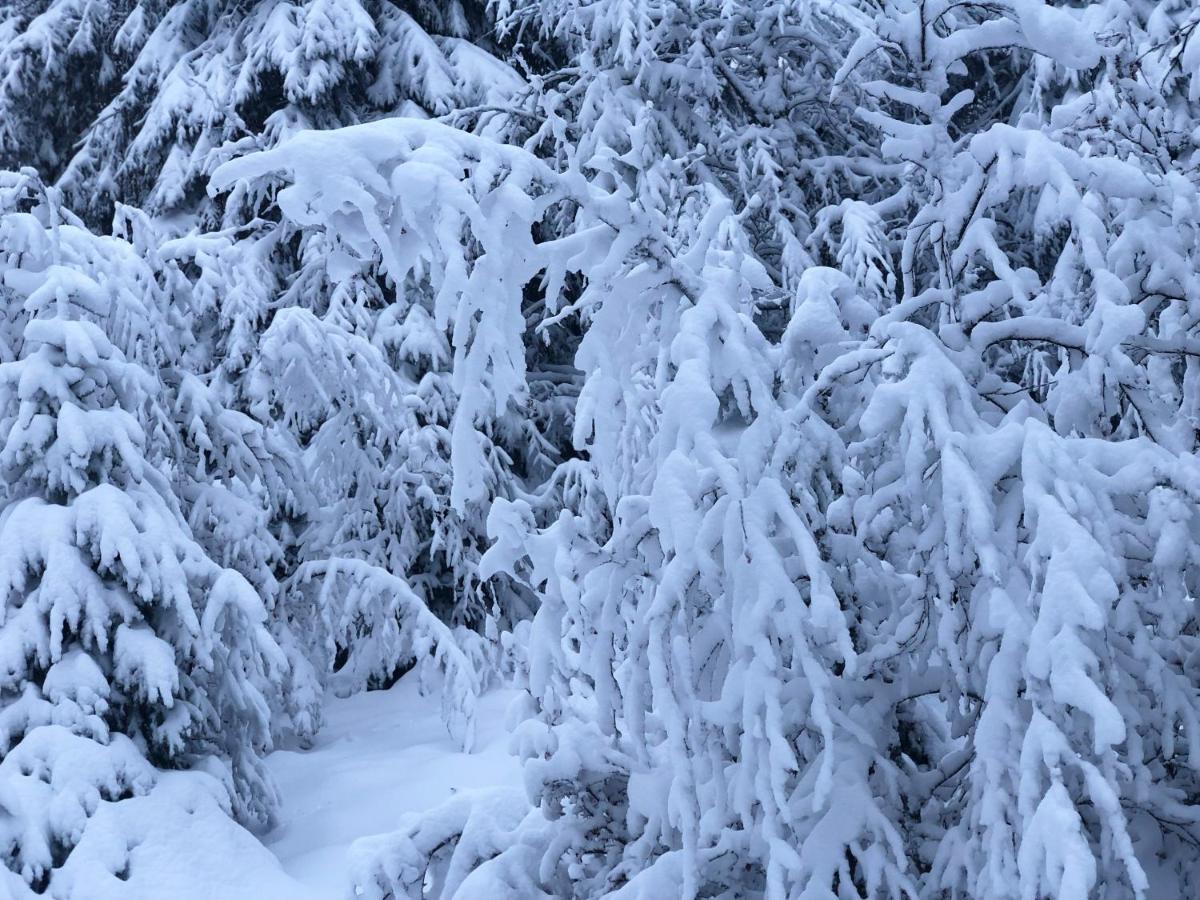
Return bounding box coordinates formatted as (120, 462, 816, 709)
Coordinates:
(78, 676, 520, 900)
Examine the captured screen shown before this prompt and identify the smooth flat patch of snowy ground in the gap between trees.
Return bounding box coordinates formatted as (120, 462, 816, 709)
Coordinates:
(265, 678, 520, 900)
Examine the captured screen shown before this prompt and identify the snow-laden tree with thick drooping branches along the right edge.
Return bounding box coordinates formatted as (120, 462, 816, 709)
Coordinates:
(846, 2, 1200, 896)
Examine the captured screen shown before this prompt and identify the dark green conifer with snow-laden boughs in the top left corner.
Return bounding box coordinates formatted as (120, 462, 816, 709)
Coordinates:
(0, 0, 511, 221)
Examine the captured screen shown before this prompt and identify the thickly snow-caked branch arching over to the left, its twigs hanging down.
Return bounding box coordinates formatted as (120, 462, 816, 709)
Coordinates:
(212, 120, 566, 511)
